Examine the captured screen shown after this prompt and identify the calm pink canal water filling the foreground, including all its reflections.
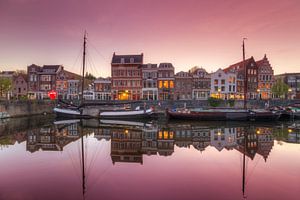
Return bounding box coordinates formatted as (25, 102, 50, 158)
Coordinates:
(0, 116, 300, 200)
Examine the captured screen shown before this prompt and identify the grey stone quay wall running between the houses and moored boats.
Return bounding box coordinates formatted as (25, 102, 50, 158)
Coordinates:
(0, 100, 300, 119)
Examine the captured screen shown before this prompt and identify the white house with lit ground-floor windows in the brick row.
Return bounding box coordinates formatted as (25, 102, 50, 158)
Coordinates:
(210, 69, 236, 99)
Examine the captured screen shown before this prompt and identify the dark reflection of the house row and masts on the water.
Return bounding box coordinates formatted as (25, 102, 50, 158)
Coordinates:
(0, 118, 300, 199)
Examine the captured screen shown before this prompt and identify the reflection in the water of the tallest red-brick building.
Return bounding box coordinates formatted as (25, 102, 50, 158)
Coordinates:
(111, 129, 143, 164)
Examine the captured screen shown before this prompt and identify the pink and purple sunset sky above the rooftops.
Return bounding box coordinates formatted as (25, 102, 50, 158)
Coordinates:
(0, 0, 300, 76)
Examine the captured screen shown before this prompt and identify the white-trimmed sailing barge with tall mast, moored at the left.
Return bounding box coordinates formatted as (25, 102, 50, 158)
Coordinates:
(53, 32, 154, 119)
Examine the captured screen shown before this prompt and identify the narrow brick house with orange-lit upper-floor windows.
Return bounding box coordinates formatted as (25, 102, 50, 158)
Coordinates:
(157, 63, 175, 100)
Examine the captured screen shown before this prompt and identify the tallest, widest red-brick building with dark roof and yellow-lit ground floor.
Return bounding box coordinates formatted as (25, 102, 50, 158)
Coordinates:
(111, 53, 143, 100)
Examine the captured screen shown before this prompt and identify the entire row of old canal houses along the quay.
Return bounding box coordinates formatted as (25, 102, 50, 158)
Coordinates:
(0, 53, 300, 100)
